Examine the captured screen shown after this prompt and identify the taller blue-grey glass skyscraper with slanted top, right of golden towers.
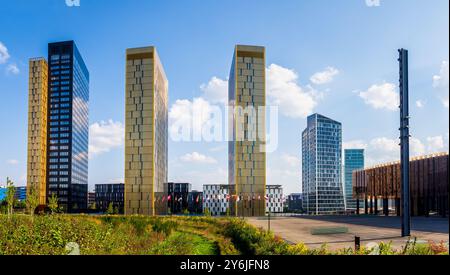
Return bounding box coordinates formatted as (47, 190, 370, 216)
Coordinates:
(302, 114, 345, 215)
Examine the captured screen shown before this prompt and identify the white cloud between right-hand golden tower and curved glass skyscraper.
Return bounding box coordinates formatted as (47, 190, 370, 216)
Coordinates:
(266, 64, 318, 118)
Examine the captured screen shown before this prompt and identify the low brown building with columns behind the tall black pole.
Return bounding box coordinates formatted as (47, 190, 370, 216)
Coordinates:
(353, 153, 449, 217)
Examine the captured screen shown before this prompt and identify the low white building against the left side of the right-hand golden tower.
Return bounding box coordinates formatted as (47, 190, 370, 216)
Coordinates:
(203, 184, 229, 216)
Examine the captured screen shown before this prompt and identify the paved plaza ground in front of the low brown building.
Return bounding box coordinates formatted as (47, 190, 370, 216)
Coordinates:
(247, 216, 449, 252)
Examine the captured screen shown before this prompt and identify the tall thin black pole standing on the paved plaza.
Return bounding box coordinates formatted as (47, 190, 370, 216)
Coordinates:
(398, 49, 411, 237)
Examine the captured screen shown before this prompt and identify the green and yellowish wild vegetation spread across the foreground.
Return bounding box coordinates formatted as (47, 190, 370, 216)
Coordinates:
(0, 214, 448, 255)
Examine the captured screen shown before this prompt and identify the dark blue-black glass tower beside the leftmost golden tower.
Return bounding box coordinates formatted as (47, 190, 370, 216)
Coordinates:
(47, 41, 89, 212)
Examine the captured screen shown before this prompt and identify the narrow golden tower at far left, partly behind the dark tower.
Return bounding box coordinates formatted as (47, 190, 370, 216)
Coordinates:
(27, 58, 48, 206)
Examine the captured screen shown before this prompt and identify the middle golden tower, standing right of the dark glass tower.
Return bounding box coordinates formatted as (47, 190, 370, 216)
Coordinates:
(124, 47, 169, 215)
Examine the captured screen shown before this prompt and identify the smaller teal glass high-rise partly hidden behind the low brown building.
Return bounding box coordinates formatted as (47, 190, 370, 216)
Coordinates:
(344, 149, 364, 210)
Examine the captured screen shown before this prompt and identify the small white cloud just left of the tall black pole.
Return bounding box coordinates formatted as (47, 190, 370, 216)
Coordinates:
(359, 83, 400, 111)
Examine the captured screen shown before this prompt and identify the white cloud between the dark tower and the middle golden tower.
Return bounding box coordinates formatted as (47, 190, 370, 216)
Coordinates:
(89, 119, 125, 156)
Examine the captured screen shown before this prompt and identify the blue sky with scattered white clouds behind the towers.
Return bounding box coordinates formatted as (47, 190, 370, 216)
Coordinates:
(0, 0, 449, 193)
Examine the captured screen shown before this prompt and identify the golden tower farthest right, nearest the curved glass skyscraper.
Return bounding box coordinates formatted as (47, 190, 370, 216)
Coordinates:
(228, 45, 266, 217)
